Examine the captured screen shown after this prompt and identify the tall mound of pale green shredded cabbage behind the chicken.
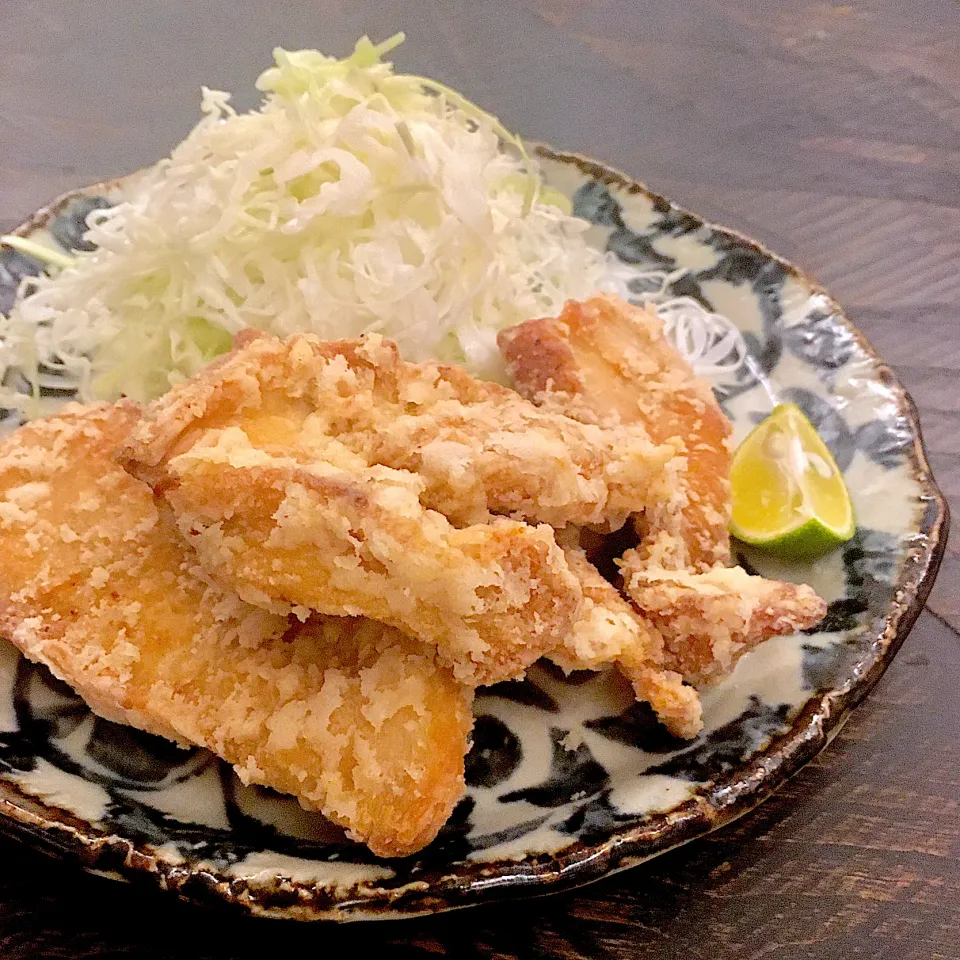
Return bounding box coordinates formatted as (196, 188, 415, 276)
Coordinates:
(0, 35, 636, 406)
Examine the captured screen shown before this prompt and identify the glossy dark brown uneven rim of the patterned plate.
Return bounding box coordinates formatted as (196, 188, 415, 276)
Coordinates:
(0, 144, 950, 921)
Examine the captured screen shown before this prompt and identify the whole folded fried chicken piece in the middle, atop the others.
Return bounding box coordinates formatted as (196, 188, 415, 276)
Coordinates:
(124, 335, 675, 683)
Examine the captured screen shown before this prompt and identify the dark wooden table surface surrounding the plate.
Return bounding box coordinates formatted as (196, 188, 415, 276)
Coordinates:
(0, 0, 960, 960)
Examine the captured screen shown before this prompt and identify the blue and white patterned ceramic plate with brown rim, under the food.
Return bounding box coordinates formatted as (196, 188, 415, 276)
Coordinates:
(0, 148, 948, 920)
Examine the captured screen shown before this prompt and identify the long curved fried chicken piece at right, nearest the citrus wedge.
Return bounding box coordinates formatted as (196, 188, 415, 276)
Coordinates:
(498, 296, 824, 685)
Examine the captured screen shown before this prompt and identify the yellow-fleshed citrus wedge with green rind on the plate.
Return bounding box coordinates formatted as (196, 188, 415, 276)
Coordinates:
(730, 403, 857, 560)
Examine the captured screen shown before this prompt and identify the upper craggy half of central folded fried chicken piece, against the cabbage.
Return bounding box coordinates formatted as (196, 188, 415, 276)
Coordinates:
(127, 335, 676, 527)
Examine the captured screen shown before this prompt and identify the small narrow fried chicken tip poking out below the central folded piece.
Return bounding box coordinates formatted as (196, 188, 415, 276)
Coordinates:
(550, 546, 703, 739)
